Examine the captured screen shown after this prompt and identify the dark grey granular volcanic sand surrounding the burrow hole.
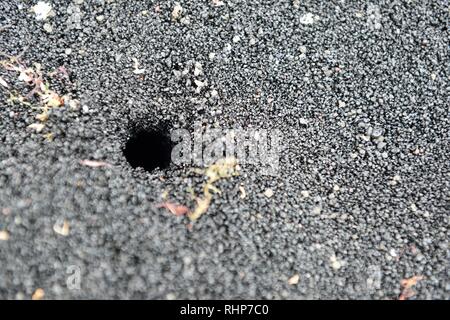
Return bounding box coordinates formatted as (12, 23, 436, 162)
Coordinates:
(0, 0, 450, 299)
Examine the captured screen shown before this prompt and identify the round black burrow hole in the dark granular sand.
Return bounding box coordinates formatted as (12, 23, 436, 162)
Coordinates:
(124, 129, 173, 172)
